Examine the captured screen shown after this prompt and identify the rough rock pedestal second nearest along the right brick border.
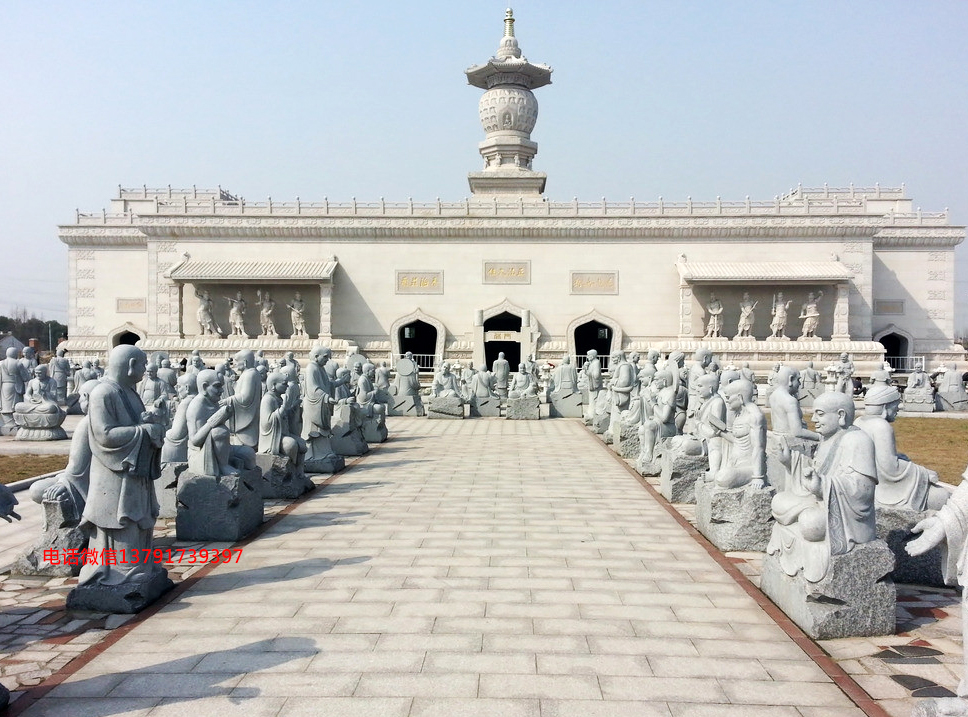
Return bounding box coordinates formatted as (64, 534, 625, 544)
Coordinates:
(696, 480, 776, 552)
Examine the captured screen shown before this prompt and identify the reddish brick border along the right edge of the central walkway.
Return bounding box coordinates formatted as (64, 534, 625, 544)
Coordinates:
(595, 441, 891, 717)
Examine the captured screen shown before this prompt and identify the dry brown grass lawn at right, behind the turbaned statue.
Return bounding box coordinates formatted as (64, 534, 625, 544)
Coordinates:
(894, 418, 968, 485)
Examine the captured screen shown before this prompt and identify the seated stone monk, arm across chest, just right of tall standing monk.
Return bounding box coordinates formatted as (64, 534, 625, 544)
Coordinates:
(185, 369, 255, 478)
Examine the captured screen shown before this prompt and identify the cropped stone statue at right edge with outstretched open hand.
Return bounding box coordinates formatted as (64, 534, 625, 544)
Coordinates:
(905, 469, 968, 717)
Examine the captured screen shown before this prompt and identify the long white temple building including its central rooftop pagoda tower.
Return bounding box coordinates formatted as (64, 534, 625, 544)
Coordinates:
(59, 11, 965, 371)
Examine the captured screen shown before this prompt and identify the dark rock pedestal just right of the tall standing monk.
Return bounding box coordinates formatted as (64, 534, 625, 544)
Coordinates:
(175, 468, 263, 543)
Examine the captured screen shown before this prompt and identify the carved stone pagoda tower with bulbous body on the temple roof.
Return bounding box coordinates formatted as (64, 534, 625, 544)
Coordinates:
(465, 8, 551, 197)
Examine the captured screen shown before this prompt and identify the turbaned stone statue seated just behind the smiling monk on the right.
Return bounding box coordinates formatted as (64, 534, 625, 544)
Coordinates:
(854, 383, 950, 511)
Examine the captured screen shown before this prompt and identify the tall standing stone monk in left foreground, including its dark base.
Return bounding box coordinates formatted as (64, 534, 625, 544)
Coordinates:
(67, 345, 172, 613)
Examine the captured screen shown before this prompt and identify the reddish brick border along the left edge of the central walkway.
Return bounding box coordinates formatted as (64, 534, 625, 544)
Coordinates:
(3, 448, 374, 717)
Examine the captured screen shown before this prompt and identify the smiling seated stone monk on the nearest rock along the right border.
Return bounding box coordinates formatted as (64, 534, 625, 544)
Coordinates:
(767, 392, 877, 582)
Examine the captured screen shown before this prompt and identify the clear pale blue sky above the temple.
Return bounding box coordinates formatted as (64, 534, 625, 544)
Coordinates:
(0, 0, 968, 335)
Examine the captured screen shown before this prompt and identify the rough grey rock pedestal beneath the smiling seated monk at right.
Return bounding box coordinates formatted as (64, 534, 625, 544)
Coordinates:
(760, 540, 897, 640)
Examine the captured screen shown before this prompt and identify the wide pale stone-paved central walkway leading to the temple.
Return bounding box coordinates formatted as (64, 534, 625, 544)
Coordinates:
(5, 419, 900, 717)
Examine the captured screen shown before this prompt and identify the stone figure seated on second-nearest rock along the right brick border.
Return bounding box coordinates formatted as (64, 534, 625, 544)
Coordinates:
(710, 379, 766, 488)
